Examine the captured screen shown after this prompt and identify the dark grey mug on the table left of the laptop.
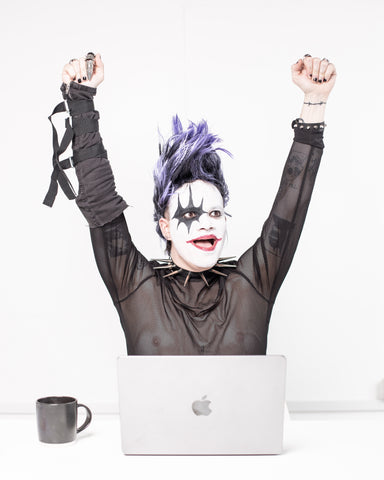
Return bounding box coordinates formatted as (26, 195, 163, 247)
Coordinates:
(36, 397, 92, 443)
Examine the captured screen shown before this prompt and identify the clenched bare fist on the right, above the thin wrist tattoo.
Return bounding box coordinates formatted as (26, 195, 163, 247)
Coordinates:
(291, 56, 336, 100)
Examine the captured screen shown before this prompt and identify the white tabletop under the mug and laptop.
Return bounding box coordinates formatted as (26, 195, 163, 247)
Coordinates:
(0, 413, 384, 480)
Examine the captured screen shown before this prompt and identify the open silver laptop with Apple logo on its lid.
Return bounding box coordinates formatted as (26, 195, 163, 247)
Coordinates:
(118, 355, 286, 455)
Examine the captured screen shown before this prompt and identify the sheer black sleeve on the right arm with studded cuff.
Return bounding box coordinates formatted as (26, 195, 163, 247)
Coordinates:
(238, 121, 324, 303)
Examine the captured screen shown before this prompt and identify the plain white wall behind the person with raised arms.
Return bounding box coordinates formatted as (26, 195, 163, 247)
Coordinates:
(0, 0, 384, 412)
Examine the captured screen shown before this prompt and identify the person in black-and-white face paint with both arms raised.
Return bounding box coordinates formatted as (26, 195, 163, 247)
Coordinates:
(44, 54, 336, 355)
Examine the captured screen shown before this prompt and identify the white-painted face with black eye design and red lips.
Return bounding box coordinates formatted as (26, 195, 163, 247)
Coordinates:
(168, 180, 227, 272)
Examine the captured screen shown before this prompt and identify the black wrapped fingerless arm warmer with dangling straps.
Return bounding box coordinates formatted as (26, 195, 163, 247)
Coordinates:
(44, 82, 127, 228)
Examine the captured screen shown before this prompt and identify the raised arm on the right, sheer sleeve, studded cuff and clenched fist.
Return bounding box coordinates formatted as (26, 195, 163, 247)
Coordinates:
(238, 56, 336, 304)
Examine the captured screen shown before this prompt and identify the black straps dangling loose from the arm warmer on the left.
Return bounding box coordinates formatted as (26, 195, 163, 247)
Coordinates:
(43, 102, 76, 207)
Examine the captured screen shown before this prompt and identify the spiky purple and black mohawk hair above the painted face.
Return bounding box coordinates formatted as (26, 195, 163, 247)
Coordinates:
(153, 115, 232, 238)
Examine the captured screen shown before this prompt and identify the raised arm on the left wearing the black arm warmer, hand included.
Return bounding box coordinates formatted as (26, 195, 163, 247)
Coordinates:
(61, 54, 152, 303)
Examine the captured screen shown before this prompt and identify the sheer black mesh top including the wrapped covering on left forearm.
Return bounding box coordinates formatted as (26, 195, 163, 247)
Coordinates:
(64, 83, 323, 355)
